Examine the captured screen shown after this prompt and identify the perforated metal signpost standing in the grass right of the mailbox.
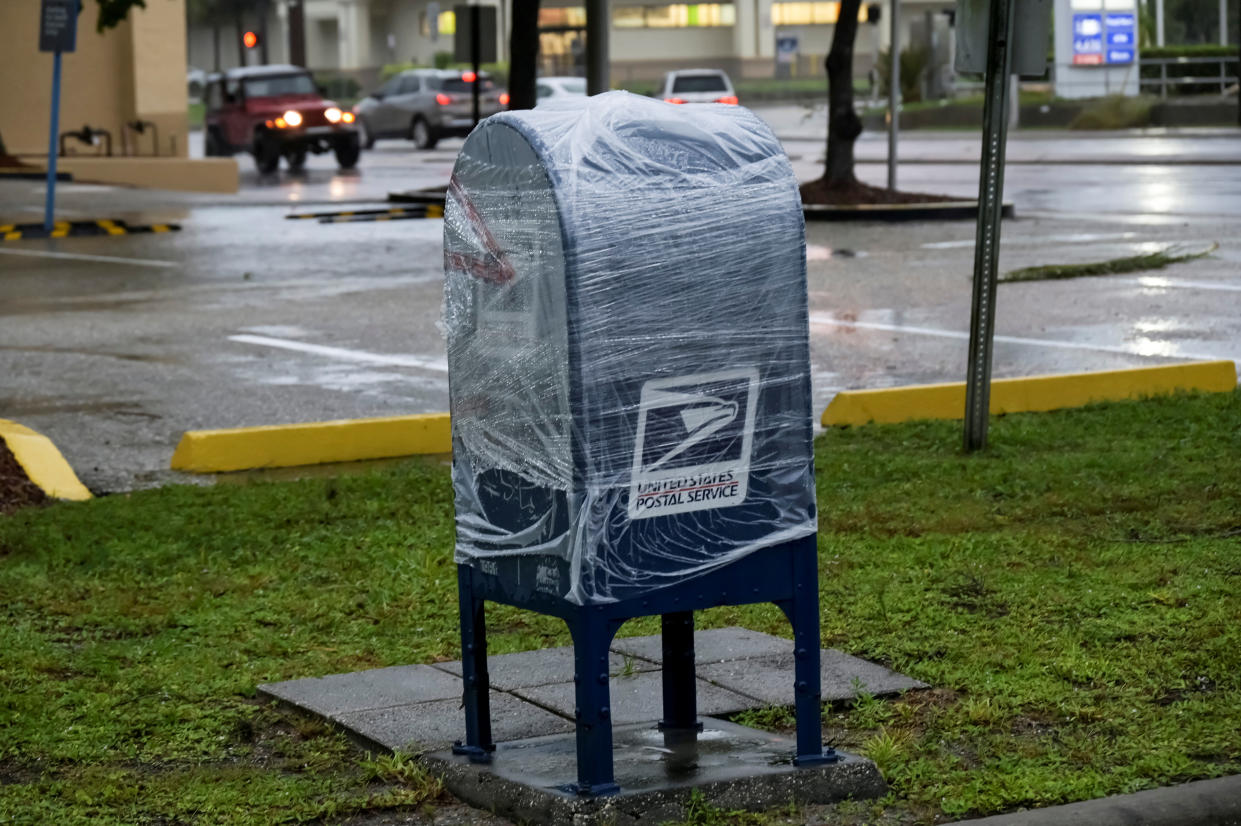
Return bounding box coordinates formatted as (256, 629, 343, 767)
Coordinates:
(965, 0, 1015, 451)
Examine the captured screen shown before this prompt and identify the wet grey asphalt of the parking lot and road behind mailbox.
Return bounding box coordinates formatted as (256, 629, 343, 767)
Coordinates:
(0, 107, 1241, 491)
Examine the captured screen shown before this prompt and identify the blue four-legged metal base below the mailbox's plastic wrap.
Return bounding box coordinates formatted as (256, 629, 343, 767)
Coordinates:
(453, 536, 839, 796)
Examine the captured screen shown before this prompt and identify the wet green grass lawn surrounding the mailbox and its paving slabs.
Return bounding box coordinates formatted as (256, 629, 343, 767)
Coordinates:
(0, 393, 1241, 826)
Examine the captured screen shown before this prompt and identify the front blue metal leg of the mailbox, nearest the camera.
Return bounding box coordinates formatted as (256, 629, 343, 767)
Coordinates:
(570, 609, 621, 797)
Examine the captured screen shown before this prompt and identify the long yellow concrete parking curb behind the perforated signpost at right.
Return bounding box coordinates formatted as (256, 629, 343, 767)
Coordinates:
(823, 361, 1237, 428)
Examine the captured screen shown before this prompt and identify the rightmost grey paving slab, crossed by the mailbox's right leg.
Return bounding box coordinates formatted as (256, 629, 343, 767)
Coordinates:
(697, 649, 927, 706)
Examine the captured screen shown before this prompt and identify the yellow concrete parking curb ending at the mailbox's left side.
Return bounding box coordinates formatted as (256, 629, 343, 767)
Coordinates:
(172, 413, 453, 474)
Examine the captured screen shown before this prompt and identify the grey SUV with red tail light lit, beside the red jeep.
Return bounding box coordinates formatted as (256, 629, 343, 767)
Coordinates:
(354, 69, 509, 149)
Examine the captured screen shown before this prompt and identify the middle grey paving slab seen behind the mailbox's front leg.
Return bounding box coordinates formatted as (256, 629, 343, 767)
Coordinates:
(513, 671, 754, 726)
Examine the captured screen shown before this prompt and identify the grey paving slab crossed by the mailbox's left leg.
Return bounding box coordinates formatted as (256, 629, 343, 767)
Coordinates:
(334, 691, 573, 753)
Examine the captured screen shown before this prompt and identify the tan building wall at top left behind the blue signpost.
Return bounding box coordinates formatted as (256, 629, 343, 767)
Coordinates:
(0, 0, 187, 158)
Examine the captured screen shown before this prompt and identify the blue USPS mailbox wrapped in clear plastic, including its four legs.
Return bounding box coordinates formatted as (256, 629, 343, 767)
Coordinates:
(444, 92, 835, 795)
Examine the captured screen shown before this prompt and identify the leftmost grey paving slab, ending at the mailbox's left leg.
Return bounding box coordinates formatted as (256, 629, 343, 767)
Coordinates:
(258, 665, 462, 719)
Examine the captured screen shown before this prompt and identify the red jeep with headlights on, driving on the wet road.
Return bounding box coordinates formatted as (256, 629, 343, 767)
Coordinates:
(205, 66, 361, 175)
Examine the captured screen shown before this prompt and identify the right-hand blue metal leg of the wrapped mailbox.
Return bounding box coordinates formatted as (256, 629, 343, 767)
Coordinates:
(779, 544, 840, 765)
